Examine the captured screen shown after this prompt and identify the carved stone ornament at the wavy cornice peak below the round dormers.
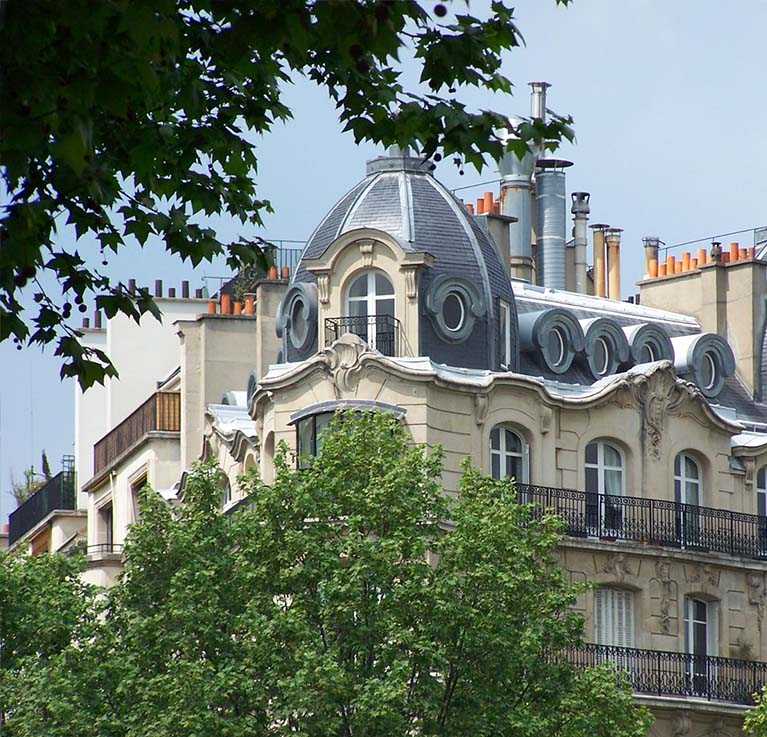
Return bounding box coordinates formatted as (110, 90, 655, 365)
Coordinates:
(626, 363, 703, 460)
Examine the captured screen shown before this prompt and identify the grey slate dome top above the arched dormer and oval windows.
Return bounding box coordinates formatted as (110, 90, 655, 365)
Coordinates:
(294, 147, 514, 313)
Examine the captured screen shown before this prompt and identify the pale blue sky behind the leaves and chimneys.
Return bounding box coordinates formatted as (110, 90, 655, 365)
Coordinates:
(0, 0, 767, 521)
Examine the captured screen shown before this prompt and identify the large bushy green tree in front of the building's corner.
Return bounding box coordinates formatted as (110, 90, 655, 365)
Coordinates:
(6, 414, 649, 737)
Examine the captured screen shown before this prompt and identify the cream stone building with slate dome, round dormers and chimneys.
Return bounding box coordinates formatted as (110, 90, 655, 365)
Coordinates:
(9, 83, 767, 737)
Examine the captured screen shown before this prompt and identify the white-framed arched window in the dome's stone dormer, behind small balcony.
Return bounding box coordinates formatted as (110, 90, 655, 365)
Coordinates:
(346, 271, 396, 356)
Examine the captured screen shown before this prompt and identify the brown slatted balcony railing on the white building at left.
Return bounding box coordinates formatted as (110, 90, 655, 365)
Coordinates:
(93, 392, 181, 476)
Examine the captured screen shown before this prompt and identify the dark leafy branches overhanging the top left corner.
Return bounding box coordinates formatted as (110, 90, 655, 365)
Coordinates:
(0, 0, 572, 388)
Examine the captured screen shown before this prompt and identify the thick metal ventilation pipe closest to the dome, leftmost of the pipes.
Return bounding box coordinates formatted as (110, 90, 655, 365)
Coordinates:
(498, 118, 535, 281)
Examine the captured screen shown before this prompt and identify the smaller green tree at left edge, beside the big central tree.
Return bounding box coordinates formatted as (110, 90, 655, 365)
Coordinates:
(0, 552, 94, 737)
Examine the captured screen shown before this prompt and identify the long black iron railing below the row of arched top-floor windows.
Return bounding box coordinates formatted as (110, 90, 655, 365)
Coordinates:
(517, 484, 767, 559)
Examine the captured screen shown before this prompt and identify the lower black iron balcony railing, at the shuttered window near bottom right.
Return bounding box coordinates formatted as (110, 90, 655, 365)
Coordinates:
(565, 644, 767, 704)
